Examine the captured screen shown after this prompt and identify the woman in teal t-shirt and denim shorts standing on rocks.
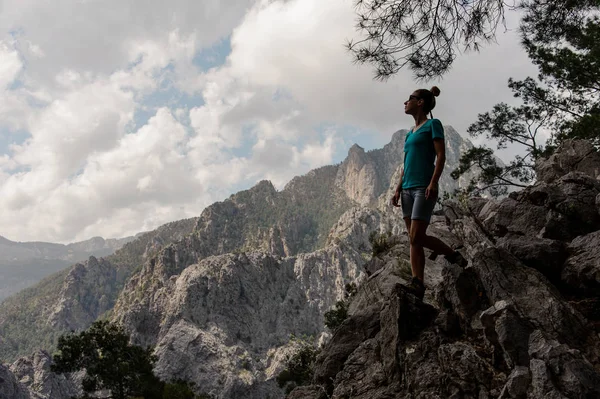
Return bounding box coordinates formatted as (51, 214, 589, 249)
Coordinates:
(392, 86, 466, 299)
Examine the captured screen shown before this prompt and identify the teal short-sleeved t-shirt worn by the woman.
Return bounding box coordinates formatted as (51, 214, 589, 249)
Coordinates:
(402, 119, 444, 189)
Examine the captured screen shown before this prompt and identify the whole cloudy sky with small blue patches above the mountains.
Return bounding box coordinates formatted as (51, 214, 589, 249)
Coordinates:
(0, 0, 535, 243)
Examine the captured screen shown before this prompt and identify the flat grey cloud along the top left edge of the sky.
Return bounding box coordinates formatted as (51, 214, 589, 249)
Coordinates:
(0, 0, 251, 87)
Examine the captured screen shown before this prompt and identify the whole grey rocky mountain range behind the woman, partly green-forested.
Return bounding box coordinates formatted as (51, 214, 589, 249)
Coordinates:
(0, 126, 490, 399)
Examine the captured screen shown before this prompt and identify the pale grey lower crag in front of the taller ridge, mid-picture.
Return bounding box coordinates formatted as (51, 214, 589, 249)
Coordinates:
(115, 243, 364, 399)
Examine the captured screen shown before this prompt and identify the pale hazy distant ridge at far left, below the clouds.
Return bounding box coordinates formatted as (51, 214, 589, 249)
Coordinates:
(0, 236, 137, 301)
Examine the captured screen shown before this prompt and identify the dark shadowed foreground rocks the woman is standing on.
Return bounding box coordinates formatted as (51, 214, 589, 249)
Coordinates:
(289, 142, 600, 399)
